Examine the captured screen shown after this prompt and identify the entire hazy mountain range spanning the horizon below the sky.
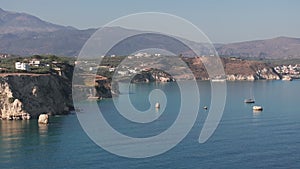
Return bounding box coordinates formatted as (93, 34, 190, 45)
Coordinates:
(0, 8, 300, 59)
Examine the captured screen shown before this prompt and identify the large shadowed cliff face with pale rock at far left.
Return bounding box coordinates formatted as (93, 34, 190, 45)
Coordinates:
(0, 74, 72, 119)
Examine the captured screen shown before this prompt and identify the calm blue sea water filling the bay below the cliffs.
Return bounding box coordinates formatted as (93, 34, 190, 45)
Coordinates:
(0, 80, 300, 169)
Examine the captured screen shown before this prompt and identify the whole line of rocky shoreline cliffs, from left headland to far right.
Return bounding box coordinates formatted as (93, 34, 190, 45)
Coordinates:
(0, 58, 290, 120)
